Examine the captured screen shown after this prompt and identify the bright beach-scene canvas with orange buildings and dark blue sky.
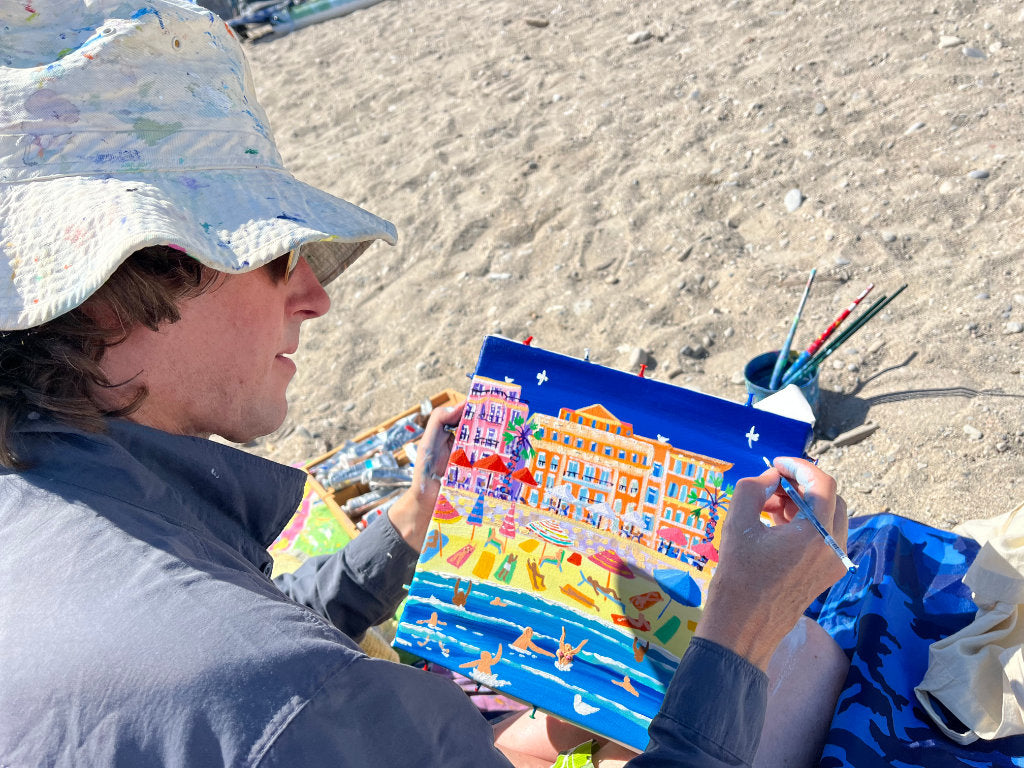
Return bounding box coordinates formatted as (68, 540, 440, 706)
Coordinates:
(394, 337, 810, 750)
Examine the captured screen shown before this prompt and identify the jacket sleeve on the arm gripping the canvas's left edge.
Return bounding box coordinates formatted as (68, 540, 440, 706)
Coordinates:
(273, 515, 419, 640)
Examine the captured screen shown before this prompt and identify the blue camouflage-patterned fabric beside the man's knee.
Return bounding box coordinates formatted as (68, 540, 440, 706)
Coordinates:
(808, 514, 1024, 768)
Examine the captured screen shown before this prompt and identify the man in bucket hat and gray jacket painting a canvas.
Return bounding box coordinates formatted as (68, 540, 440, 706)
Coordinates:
(0, 0, 846, 768)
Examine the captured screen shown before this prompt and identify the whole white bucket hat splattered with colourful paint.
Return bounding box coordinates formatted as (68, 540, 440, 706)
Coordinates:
(0, 0, 396, 331)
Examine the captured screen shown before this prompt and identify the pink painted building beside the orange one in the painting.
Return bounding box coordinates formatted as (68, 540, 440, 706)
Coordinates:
(447, 376, 529, 499)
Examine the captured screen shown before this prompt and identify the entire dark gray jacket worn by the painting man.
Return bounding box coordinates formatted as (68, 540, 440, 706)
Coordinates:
(0, 421, 765, 768)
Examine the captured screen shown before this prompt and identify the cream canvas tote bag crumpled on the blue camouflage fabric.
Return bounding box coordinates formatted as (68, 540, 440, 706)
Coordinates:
(914, 504, 1024, 744)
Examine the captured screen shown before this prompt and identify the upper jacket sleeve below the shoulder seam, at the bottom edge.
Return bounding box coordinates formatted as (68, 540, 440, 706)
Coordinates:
(254, 655, 512, 768)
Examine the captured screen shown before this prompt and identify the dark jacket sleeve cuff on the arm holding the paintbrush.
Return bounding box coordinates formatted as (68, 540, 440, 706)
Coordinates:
(627, 638, 768, 768)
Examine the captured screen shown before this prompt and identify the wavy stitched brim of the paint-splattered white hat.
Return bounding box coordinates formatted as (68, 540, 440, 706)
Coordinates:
(0, 168, 397, 331)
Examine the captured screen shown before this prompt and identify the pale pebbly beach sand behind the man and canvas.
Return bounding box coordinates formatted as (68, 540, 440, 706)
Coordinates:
(235, 0, 1024, 527)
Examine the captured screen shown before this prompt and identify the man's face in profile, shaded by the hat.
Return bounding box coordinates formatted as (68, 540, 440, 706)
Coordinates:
(100, 257, 331, 442)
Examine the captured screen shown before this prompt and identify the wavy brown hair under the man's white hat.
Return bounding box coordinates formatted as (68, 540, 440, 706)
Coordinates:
(0, 246, 217, 469)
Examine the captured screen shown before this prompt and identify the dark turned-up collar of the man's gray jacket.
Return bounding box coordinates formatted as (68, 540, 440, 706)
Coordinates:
(17, 419, 306, 570)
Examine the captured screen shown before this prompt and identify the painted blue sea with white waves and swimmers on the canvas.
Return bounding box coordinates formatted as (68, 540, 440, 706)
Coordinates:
(395, 572, 692, 749)
